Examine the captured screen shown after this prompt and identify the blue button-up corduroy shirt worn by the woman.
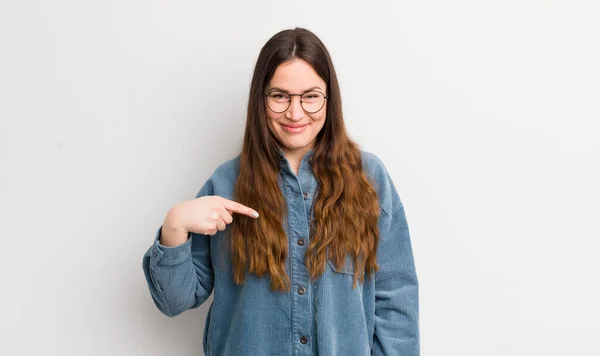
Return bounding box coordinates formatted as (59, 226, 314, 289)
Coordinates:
(143, 150, 420, 356)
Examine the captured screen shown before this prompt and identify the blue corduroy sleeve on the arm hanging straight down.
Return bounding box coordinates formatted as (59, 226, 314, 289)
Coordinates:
(372, 162, 420, 356)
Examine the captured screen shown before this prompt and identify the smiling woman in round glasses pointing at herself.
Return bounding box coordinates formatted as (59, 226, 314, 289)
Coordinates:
(143, 28, 419, 356)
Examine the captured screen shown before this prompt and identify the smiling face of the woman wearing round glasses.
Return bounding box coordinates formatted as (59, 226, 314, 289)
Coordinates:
(265, 59, 327, 155)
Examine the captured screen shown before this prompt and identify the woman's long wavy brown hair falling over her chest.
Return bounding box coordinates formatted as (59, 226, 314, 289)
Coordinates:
(230, 28, 379, 291)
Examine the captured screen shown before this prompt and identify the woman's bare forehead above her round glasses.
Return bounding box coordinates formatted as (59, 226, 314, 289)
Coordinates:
(269, 59, 325, 93)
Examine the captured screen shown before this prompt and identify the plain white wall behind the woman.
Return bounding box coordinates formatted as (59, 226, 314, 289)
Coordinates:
(0, 0, 600, 356)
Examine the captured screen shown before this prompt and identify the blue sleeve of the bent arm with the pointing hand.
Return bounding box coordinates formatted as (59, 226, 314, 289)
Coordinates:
(142, 180, 214, 317)
